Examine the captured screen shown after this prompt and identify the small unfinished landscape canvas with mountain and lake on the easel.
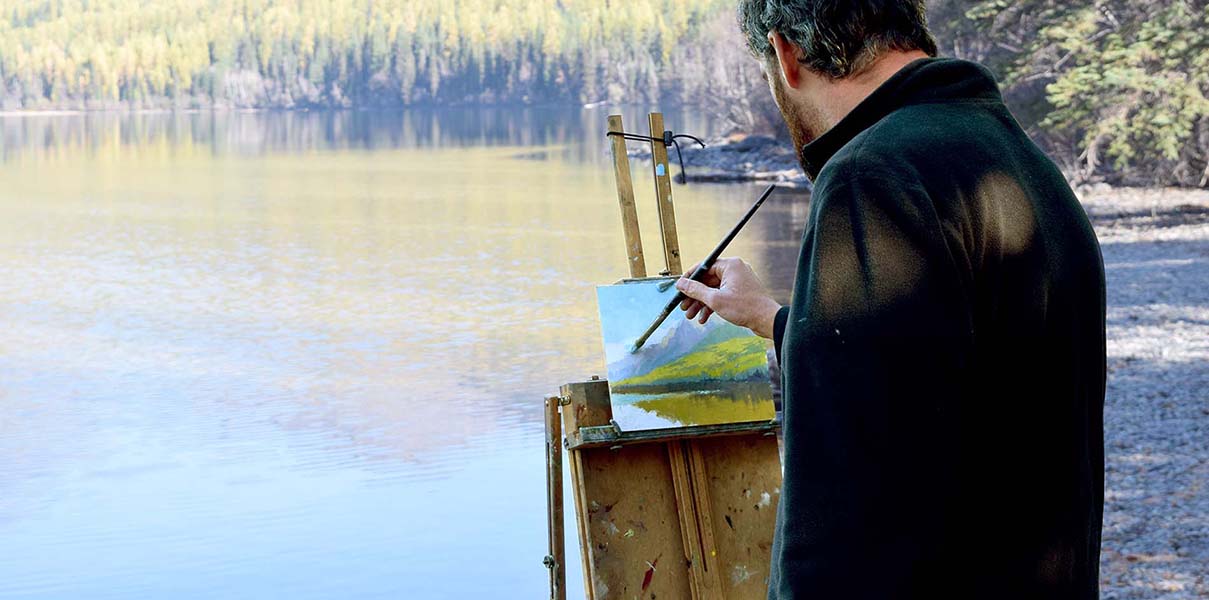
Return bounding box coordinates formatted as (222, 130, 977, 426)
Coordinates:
(596, 278, 774, 431)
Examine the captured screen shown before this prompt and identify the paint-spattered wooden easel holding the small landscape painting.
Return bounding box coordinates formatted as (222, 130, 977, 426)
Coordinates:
(545, 113, 781, 600)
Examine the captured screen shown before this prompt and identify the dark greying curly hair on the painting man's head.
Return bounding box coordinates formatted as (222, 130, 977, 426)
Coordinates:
(739, 0, 936, 79)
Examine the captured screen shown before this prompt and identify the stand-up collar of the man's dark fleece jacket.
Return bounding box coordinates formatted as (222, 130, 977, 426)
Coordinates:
(800, 58, 1003, 181)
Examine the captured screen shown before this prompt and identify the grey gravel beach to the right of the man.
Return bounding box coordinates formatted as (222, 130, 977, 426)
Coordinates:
(1080, 188, 1209, 600)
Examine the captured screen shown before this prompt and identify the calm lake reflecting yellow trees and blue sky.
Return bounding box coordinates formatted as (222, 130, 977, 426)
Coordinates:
(0, 106, 806, 599)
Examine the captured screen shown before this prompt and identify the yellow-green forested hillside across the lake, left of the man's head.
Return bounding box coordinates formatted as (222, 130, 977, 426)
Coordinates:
(0, 0, 731, 108)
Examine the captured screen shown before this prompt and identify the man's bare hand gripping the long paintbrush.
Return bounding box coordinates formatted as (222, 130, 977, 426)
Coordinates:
(676, 259, 781, 339)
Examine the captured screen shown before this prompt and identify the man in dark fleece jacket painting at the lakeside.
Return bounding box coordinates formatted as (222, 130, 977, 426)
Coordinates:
(677, 0, 1105, 600)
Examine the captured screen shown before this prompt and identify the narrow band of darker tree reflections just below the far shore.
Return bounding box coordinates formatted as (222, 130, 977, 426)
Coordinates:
(0, 108, 713, 163)
